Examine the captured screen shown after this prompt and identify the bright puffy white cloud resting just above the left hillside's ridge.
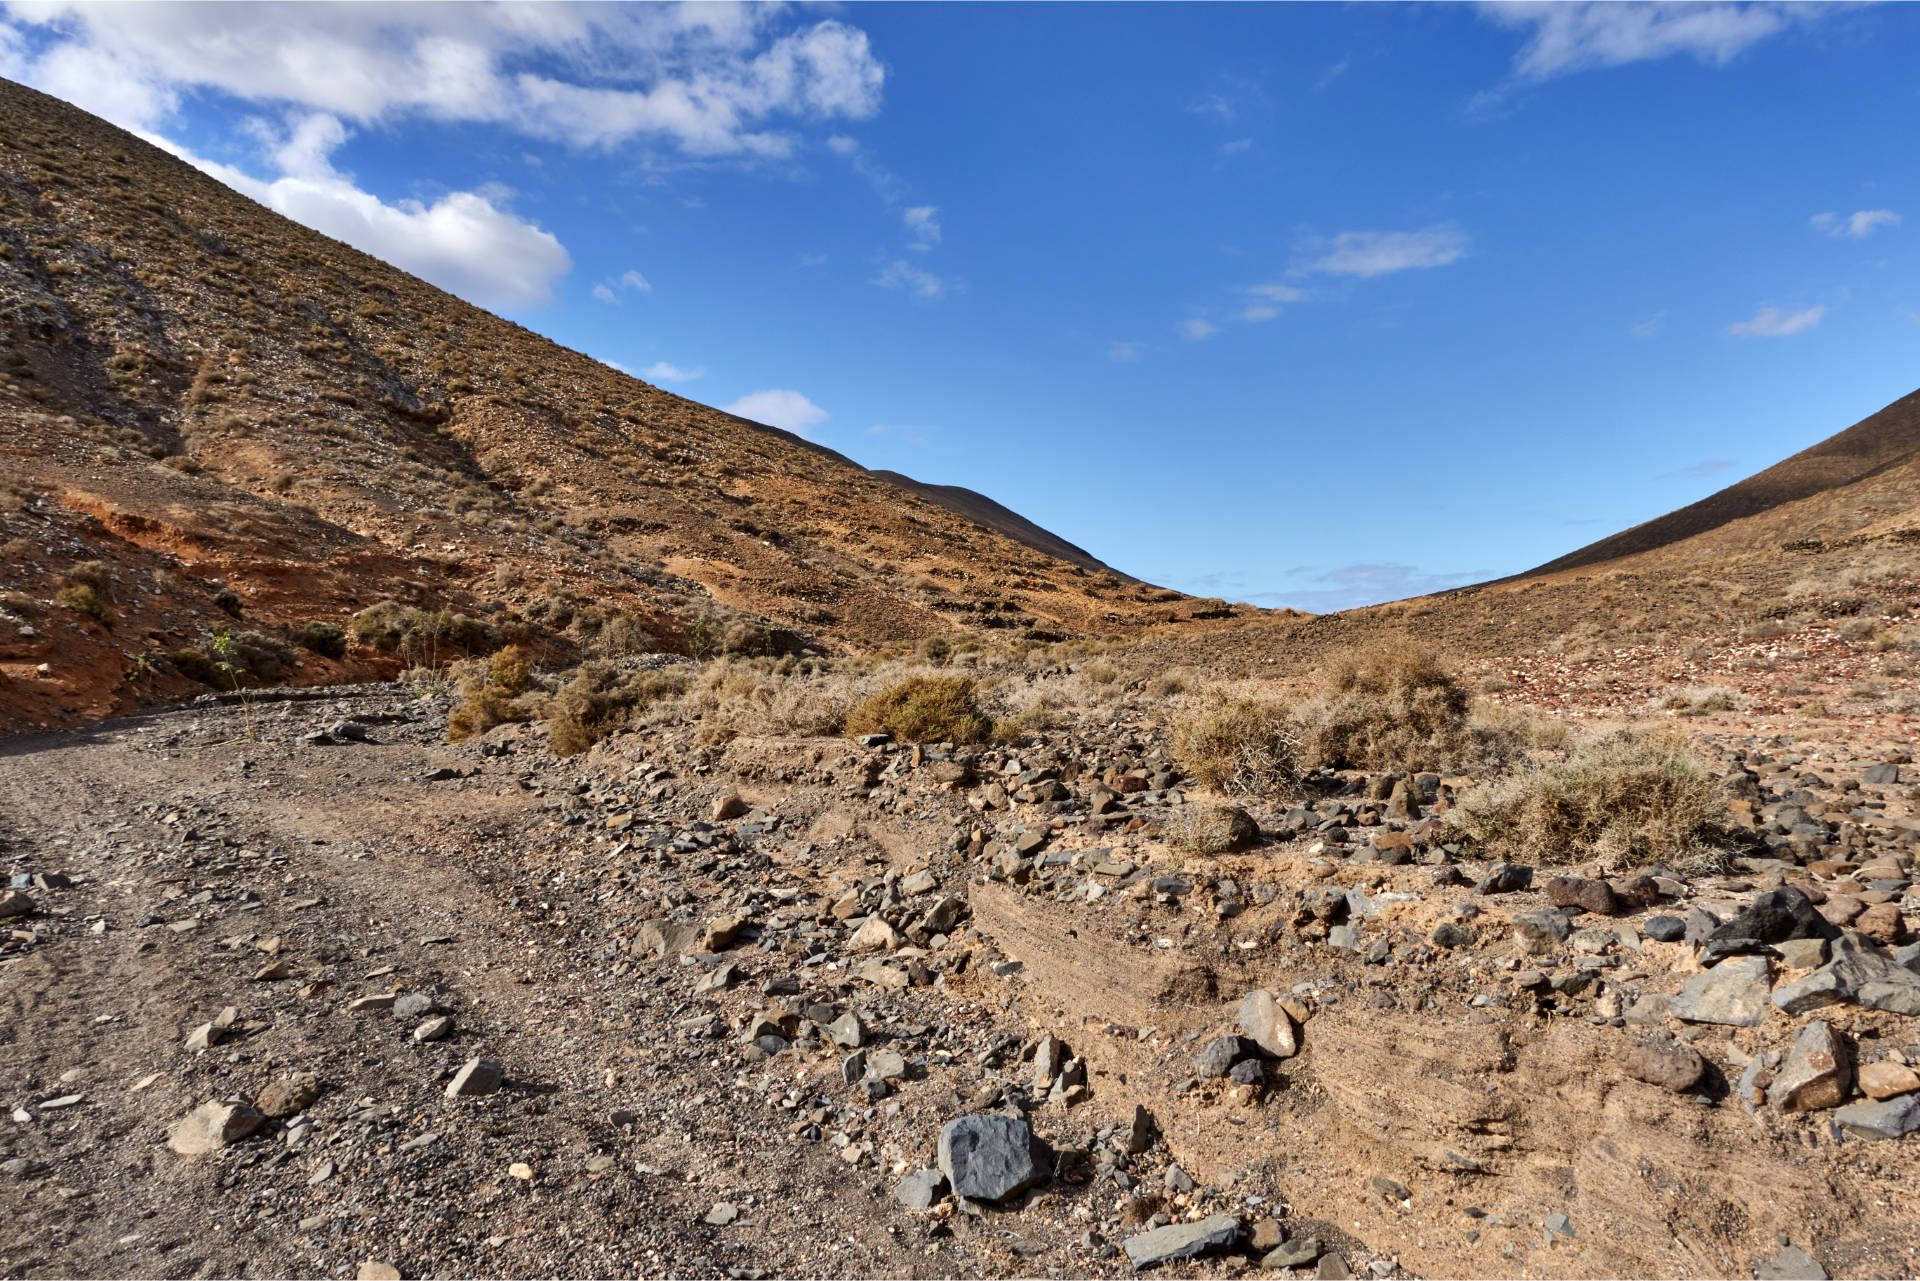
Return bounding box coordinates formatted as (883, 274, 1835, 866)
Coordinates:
(144, 115, 574, 309)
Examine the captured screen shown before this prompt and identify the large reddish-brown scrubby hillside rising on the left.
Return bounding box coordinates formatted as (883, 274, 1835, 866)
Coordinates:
(0, 81, 1198, 724)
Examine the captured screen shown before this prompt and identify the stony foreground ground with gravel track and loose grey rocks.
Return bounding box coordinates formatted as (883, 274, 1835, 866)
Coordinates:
(0, 686, 1920, 1277)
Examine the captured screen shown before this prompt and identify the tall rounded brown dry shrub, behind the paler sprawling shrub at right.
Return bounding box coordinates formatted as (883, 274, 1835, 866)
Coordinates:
(1294, 636, 1482, 770)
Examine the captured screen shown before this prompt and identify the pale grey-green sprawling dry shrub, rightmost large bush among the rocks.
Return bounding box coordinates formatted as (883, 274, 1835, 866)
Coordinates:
(1452, 730, 1726, 868)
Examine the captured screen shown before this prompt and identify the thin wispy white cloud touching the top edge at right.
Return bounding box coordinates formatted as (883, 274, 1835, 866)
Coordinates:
(1480, 0, 1818, 85)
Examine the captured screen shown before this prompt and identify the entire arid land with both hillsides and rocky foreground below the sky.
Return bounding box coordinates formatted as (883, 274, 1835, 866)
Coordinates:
(0, 83, 1920, 1279)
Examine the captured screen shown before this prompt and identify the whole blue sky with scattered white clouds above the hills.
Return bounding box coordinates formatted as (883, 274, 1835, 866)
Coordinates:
(0, 4, 1920, 609)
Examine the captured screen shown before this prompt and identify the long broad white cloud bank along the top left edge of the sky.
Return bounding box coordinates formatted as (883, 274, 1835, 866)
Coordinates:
(10, 2, 885, 156)
